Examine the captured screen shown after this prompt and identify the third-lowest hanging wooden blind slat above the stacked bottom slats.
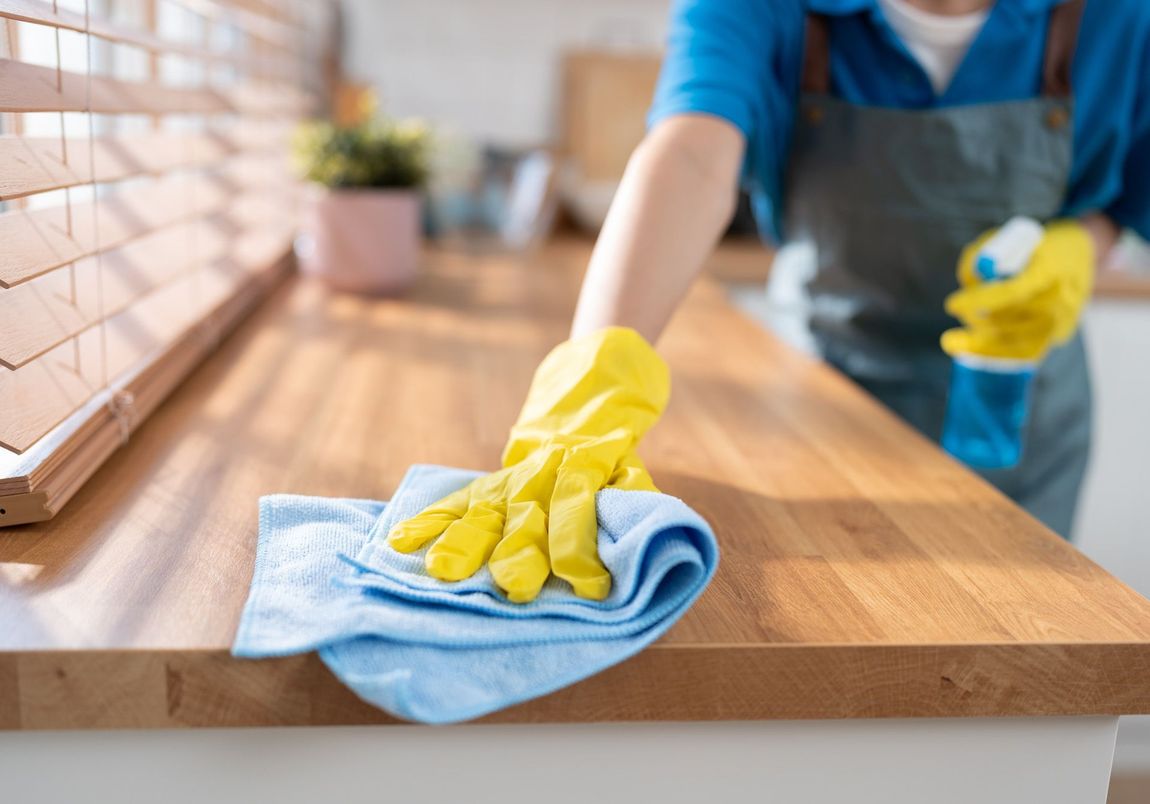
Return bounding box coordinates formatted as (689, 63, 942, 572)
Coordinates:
(0, 156, 296, 288)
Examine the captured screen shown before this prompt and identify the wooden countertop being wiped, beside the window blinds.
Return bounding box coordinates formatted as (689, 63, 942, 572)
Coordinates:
(0, 244, 1150, 728)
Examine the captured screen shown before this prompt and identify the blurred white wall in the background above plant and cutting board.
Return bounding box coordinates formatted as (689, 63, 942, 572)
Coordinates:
(335, 0, 669, 146)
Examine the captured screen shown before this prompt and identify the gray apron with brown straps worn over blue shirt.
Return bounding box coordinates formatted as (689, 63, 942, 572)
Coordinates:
(783, 0, 1090, 537)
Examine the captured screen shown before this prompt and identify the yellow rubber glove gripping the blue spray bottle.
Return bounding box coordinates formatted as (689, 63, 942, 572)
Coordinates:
(942, 220, 1095, 360)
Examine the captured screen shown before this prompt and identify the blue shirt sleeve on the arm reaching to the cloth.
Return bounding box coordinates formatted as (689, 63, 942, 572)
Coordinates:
(647, 0, 772, 140)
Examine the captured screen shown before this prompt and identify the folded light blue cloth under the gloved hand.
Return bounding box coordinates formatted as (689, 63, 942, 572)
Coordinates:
(232, 466, 718, 723)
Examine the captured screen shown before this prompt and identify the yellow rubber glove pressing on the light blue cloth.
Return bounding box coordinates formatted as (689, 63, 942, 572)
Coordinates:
(388, 327, 670, 603)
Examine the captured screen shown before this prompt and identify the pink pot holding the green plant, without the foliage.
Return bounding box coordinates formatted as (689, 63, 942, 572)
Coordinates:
(300, 187, 420, 294)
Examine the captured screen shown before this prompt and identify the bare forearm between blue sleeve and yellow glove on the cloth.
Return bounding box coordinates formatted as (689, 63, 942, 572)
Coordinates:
(572, 115, 745, 342)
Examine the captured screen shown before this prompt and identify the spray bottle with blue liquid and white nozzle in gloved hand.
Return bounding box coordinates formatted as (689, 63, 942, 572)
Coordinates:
(942, 217, 1045, 469)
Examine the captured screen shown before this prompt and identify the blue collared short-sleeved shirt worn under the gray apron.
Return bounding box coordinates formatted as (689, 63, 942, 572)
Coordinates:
(650, 0, 1150, 238)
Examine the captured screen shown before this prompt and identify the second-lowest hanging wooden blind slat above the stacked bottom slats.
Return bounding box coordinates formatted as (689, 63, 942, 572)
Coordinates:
(0, 193, 290, 369)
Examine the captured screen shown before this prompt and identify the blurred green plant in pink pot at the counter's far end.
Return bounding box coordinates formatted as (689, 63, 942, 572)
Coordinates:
(294, 107, 430, 293)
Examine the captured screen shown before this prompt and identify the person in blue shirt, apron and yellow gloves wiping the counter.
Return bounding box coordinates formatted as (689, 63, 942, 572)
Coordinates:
(390, 0, 1150, 600)
